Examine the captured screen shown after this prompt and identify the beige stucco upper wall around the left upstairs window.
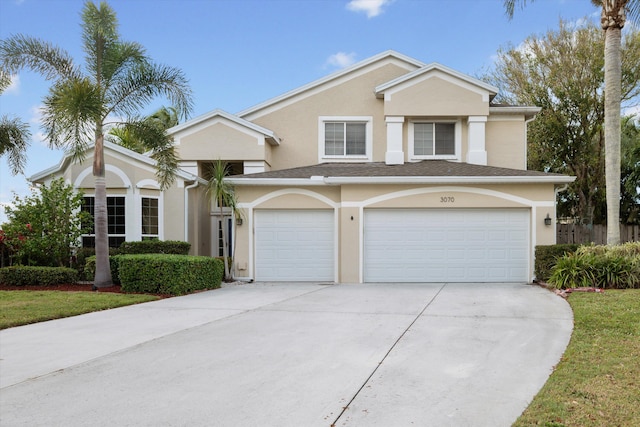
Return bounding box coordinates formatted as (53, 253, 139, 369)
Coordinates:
(251, 64, 407, 170)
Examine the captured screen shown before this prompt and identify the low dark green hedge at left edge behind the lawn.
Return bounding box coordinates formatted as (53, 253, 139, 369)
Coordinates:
(0, 265, 78, 286)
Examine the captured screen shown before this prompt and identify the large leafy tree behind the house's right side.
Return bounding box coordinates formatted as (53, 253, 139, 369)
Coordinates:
(487, 21, 640, 223)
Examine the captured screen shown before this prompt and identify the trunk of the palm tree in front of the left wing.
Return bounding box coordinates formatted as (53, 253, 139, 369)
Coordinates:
(93, 135, 113, 288)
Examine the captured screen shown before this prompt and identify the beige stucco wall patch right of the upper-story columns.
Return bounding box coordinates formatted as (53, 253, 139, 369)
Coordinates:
(485, 116, 527, 169)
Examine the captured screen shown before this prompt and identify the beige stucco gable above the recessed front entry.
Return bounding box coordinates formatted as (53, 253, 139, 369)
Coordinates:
(176, 122, 270, 165)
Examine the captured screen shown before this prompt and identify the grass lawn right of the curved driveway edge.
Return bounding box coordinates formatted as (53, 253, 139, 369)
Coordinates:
(514, 289, 640, 427)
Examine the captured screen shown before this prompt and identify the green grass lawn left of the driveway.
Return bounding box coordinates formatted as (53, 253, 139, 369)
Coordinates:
(0, 290, 159, 329)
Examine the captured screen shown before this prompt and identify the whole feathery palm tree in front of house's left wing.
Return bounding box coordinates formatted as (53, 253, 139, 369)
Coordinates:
(0, 2, 192, 288)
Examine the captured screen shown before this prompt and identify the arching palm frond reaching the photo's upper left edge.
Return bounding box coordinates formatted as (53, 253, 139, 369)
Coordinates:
(0, 34, 80, 80)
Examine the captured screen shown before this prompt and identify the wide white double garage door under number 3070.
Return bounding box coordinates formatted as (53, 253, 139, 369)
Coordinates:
(364, 209, 529, 282)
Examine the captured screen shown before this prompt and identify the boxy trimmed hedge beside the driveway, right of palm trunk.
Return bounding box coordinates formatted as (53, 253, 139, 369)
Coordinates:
(118, 254, 224, 295)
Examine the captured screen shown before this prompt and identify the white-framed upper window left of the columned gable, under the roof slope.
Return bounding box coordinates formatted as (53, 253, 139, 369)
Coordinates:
(318, 116, 373, 162)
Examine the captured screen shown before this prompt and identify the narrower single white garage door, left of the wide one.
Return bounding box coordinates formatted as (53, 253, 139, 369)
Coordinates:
(255, 210, 335, 282)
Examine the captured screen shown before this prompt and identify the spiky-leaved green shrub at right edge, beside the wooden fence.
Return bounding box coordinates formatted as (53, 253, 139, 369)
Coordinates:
(549, 243, 640, 289)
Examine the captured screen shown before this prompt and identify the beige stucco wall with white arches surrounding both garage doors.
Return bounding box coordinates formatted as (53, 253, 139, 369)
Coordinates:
(236, 184, 555, 283)
